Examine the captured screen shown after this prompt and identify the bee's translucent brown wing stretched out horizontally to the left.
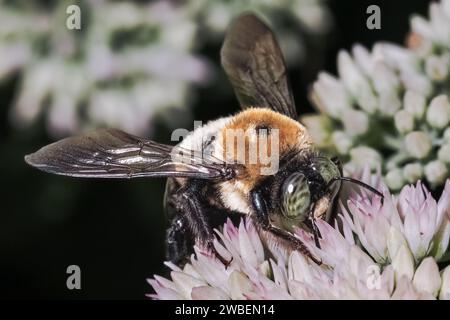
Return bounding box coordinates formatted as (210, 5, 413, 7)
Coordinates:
(25, 129, 237, 180)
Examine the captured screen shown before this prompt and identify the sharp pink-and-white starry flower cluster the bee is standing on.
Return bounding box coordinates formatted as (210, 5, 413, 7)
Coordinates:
(149, 175, 450, 299)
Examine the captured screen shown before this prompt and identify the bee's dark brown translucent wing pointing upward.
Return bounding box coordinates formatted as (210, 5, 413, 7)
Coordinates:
(221, 14, 298, 120)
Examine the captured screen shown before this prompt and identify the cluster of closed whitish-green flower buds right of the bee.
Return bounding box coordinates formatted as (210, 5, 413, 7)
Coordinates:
(303, 0, 450, 191)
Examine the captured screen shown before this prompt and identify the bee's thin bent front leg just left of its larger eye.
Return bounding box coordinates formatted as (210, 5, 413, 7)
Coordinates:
(251, 191, 322, 265)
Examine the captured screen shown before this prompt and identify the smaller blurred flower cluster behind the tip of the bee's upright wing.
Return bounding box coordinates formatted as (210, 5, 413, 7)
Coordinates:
(187, 0, 332, 64)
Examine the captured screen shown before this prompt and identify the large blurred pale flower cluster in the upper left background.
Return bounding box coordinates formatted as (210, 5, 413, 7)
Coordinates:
(0, 0, 209, 135)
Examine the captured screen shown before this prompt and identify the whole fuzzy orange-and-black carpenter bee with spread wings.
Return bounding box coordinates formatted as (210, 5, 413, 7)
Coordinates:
(25, 14, 381, 264)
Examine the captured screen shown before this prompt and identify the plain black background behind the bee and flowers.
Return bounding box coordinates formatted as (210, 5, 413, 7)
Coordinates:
(0, 0, 429, 299)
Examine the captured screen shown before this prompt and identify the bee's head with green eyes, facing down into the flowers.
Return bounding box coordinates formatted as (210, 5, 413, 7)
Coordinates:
(279, 156, 341, 229)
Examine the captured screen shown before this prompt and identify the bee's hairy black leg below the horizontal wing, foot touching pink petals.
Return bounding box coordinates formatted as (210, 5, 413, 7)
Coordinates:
(180, 181, 231, 266)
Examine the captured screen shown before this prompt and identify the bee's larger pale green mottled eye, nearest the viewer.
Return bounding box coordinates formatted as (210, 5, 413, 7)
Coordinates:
(281, 172, 311, 220)
